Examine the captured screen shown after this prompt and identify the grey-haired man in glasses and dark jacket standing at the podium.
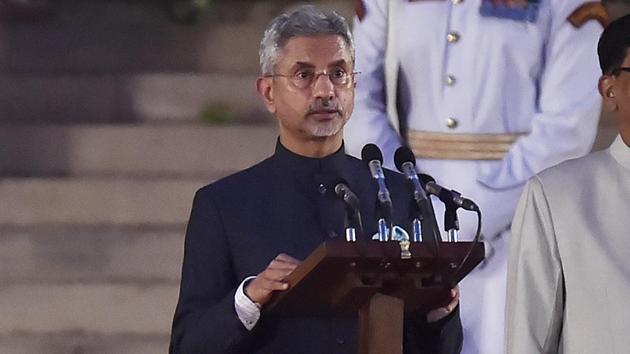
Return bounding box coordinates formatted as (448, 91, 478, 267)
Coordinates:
(170, 6, 462, 354)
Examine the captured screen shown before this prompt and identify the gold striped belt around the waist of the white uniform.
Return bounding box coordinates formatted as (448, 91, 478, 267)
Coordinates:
(408, 130, 526, 160)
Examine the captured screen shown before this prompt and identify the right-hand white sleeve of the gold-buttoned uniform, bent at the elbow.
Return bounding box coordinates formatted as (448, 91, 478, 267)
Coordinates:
(479, 0, 602, 189)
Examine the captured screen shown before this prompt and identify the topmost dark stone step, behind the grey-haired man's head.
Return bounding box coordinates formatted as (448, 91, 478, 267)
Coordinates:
(0, 0, 352, 73)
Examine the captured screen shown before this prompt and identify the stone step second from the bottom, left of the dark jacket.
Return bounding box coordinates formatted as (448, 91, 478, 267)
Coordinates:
(0, 282, 179, 336)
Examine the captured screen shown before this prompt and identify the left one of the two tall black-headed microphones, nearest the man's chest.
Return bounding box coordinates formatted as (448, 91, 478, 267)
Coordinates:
(361, 144, 392, 242)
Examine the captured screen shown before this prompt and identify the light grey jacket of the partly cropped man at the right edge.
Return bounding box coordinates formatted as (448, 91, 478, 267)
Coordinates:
(506, 137, 630, 354)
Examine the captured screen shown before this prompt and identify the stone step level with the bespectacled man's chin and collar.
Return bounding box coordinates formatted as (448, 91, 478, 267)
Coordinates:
(0, 124, 277, 177)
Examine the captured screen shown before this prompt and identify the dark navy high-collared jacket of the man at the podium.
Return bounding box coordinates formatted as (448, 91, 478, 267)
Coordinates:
(170, 143, 462, 354)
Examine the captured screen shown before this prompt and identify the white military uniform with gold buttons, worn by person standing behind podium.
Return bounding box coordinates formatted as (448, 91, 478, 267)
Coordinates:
(345, 0, 602, 354)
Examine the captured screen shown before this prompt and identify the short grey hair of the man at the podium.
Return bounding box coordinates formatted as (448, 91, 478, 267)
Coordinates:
(258, 5, 354, 75)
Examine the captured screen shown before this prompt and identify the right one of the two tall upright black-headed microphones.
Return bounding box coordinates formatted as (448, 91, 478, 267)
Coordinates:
(394, 146, 441, 251)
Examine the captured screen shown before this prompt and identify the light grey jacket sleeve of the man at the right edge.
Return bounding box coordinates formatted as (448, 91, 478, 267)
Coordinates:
(505, 177, 564, 354)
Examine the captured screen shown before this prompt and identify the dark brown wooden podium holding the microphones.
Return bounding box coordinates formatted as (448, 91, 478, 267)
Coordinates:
(264, 241, 484, 354)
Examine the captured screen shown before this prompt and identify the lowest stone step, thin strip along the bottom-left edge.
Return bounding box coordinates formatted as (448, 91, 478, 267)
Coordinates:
(0, 332, 169, 354)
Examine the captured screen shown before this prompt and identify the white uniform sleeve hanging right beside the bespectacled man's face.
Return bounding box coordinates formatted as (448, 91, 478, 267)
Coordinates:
(344, 0, 401, 168)
